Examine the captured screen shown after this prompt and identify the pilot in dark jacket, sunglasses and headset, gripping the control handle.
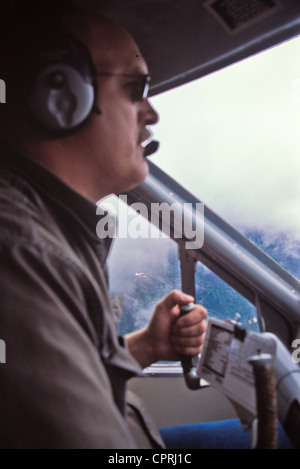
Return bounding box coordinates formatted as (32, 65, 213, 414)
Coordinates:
(0, 2, 207, 449)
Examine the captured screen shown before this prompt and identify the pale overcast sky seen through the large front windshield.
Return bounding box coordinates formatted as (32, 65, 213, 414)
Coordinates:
(152, 33, 300, 239)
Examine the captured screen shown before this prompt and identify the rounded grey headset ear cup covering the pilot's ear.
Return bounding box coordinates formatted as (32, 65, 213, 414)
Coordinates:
(19, 10, 101, 137)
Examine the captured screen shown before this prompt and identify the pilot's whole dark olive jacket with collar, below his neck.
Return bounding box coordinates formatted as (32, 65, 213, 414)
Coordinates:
(0, 150, 162, 449)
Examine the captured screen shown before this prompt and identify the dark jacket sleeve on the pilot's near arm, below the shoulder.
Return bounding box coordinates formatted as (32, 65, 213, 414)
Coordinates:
(0, 239, 136, 449)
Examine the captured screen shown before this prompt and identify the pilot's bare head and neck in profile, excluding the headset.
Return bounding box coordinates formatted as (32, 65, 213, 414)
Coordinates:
(0, 2, 158, 200)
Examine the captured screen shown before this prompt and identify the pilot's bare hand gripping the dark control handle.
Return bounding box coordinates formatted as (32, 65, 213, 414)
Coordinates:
(127, 290, 208, 368)
